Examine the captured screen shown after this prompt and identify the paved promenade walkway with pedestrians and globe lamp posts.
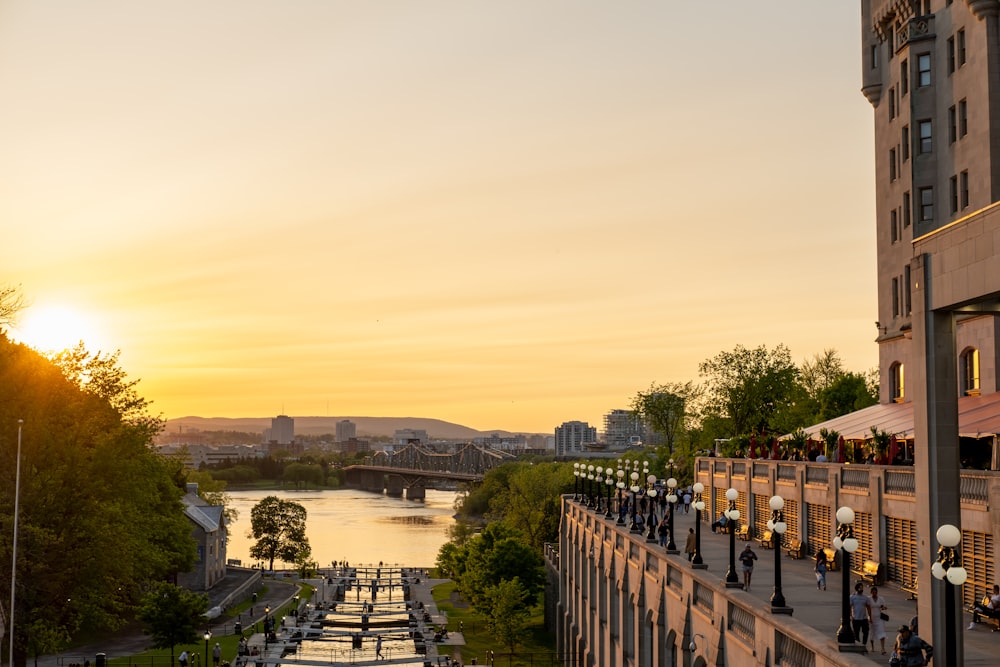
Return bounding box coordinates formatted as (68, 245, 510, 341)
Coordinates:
(652, 510, 1000, 667)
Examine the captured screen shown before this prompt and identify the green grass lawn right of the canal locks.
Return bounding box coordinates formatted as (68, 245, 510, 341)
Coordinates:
(434, 581, 562, 667)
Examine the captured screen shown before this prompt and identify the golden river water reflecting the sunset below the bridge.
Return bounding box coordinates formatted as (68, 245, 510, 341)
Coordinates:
(226, 489, 458, 569)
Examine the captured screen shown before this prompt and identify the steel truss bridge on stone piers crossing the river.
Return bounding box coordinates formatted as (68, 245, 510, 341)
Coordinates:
(344, 444, 515, 500)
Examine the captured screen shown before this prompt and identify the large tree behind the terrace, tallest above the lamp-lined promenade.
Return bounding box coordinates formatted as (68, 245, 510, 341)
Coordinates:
(698, 345, 799, 435)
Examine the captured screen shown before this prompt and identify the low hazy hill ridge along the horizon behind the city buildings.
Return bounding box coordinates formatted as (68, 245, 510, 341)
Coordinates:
(165, 416, 531, 440)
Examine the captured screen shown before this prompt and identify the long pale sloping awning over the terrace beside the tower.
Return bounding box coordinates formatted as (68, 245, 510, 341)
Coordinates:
(782, 393, 1000, 440)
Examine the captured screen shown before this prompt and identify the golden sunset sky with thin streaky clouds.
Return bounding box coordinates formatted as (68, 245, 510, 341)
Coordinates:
(0, 0, 878, 433)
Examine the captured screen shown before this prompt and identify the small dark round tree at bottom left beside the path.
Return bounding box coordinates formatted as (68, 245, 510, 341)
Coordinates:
(138, 582, 208, 665)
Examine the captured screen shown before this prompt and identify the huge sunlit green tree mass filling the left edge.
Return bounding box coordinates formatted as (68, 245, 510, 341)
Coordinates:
(0, 334, 196, 666)
